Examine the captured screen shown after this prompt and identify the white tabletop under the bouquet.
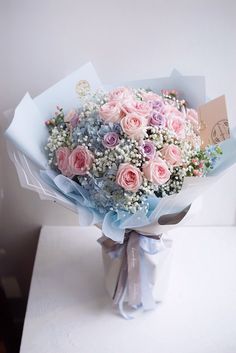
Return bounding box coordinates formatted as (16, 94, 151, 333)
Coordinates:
(21, 227, 236, 353)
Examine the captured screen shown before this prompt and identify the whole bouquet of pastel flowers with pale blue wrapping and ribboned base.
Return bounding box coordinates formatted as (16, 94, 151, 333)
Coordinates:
(5, 62, 235, 318)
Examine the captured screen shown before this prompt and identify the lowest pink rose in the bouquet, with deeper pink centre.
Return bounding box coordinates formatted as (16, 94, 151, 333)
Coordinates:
(116, 163, 142, 192)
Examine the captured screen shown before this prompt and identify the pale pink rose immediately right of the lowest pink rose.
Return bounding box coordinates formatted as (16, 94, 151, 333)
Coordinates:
(143, 158, 170, 185)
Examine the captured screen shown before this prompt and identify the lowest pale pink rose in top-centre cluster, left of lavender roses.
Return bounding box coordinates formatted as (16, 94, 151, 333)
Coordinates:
(120, 113, 147, 140)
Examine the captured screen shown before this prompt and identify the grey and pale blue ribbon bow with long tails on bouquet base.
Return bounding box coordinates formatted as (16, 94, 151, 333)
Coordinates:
(98, 231, 168, 319)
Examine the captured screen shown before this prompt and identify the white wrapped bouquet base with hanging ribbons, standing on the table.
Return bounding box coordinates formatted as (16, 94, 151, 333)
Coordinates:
(99, 232, 172, 318)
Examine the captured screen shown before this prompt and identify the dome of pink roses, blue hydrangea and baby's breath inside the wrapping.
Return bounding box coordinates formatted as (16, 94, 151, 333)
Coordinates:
(46, 87, 221, 213)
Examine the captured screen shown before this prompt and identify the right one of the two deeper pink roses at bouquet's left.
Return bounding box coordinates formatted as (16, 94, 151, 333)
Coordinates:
(69, 146, 94, 175)
